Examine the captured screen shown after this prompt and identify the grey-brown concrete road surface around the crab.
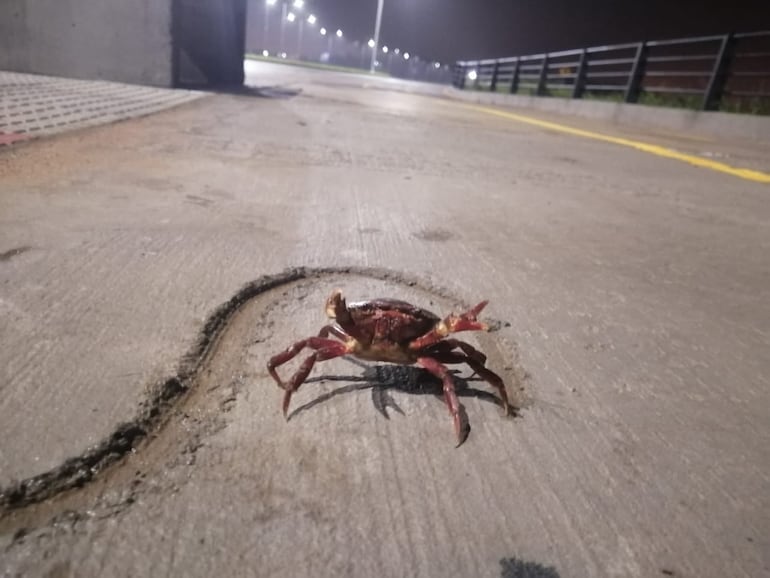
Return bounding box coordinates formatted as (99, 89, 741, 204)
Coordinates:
(0, 60, 770, 578)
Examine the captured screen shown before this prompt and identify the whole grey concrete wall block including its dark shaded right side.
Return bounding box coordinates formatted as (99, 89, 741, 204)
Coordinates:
(0, 0, 246, 86)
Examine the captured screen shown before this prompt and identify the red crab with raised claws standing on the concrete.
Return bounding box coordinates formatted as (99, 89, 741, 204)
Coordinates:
(267, 289, 511, 446)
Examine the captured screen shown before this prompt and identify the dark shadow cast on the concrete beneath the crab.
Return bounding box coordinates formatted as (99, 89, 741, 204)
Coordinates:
(288, 359, 510, 423)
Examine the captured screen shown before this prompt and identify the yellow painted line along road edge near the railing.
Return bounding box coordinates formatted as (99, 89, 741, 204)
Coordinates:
(456, 102, 770, 183)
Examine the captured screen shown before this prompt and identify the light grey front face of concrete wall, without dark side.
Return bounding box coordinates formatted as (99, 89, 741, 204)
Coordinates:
(0, 0, 172, 86)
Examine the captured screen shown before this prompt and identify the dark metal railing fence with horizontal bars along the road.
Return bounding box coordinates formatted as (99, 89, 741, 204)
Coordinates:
(453, 31, 770, 114)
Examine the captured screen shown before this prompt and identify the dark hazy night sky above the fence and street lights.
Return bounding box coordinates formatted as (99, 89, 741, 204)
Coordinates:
(274, 0, 770, 62)
